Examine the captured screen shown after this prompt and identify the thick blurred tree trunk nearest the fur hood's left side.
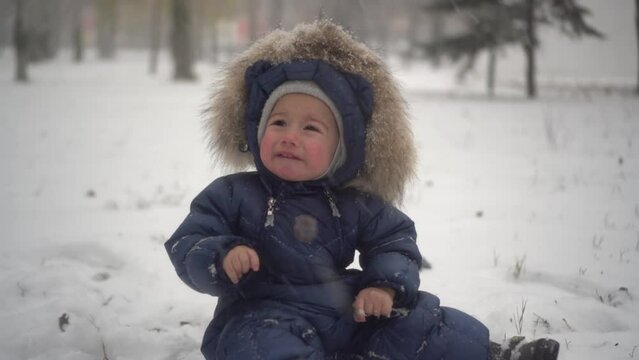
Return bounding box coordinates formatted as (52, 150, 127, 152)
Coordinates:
(171, 0, 195, 81)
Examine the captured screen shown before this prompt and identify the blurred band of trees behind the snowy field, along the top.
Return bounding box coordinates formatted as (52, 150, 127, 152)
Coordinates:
(0, 0, 639, 98)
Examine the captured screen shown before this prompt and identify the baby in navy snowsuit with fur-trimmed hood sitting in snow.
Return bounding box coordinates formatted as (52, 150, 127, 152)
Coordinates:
(165, 22, 560, 360)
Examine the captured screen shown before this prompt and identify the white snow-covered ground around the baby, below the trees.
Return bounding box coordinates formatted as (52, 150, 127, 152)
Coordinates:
(0, 48, 639, 360)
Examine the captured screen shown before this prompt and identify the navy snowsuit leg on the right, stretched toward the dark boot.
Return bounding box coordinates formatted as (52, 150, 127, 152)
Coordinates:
(352, 291, 489, 360)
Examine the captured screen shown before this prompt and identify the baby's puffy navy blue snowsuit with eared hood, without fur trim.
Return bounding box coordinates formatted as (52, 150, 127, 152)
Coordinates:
(165, 60, 488, 360)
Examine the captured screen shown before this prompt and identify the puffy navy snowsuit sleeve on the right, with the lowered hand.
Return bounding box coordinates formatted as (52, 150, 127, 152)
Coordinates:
(357, 198, 422, 308)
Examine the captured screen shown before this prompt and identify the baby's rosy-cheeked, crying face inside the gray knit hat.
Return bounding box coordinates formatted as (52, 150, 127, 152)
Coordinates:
(260, 93, 339, 181)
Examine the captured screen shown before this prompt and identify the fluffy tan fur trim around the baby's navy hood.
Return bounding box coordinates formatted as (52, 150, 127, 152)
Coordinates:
(205, 21, 416, 203)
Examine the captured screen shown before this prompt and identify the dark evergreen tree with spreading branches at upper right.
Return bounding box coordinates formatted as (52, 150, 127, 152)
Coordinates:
(422, 0, 603, 98)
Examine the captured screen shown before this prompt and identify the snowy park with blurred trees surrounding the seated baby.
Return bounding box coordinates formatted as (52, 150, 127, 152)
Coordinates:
(0, 0, 639, 360)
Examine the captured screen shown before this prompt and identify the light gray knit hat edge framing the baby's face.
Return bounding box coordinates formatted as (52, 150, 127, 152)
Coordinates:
(257, 81, 346, 178)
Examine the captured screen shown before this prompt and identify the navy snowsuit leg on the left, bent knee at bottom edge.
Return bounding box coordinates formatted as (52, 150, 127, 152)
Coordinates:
(202, 302, 324, 360)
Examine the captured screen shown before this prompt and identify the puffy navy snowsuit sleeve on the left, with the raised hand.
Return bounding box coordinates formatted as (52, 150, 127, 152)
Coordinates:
(164, 177, 255, 296)
